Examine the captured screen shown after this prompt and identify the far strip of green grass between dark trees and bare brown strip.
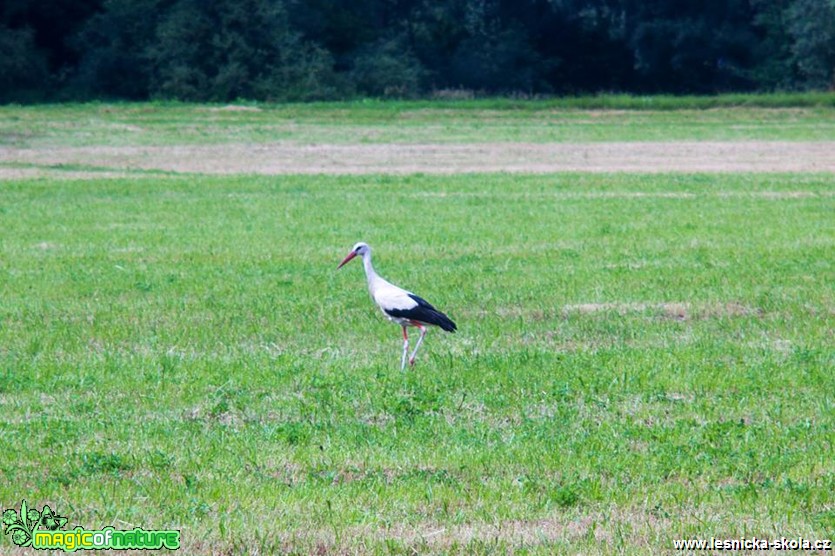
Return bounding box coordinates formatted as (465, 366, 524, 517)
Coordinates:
(0, 93, 835, 148)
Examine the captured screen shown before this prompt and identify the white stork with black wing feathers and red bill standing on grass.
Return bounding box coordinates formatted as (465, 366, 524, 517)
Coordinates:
(336, 242, 458, 370)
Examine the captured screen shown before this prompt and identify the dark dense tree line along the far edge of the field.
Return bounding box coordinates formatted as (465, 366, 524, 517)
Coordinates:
(0, 0, 835, 102)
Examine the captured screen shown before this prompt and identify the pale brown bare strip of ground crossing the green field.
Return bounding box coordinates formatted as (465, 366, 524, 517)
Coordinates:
(0, 141, 835, 179)
